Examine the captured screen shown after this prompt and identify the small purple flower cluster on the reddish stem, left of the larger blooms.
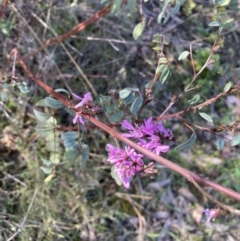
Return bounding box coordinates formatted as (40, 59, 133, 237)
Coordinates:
(72, 92, 101, 125)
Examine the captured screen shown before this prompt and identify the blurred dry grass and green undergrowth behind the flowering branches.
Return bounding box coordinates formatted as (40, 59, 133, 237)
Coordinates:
(0, 0, 240, 241)
